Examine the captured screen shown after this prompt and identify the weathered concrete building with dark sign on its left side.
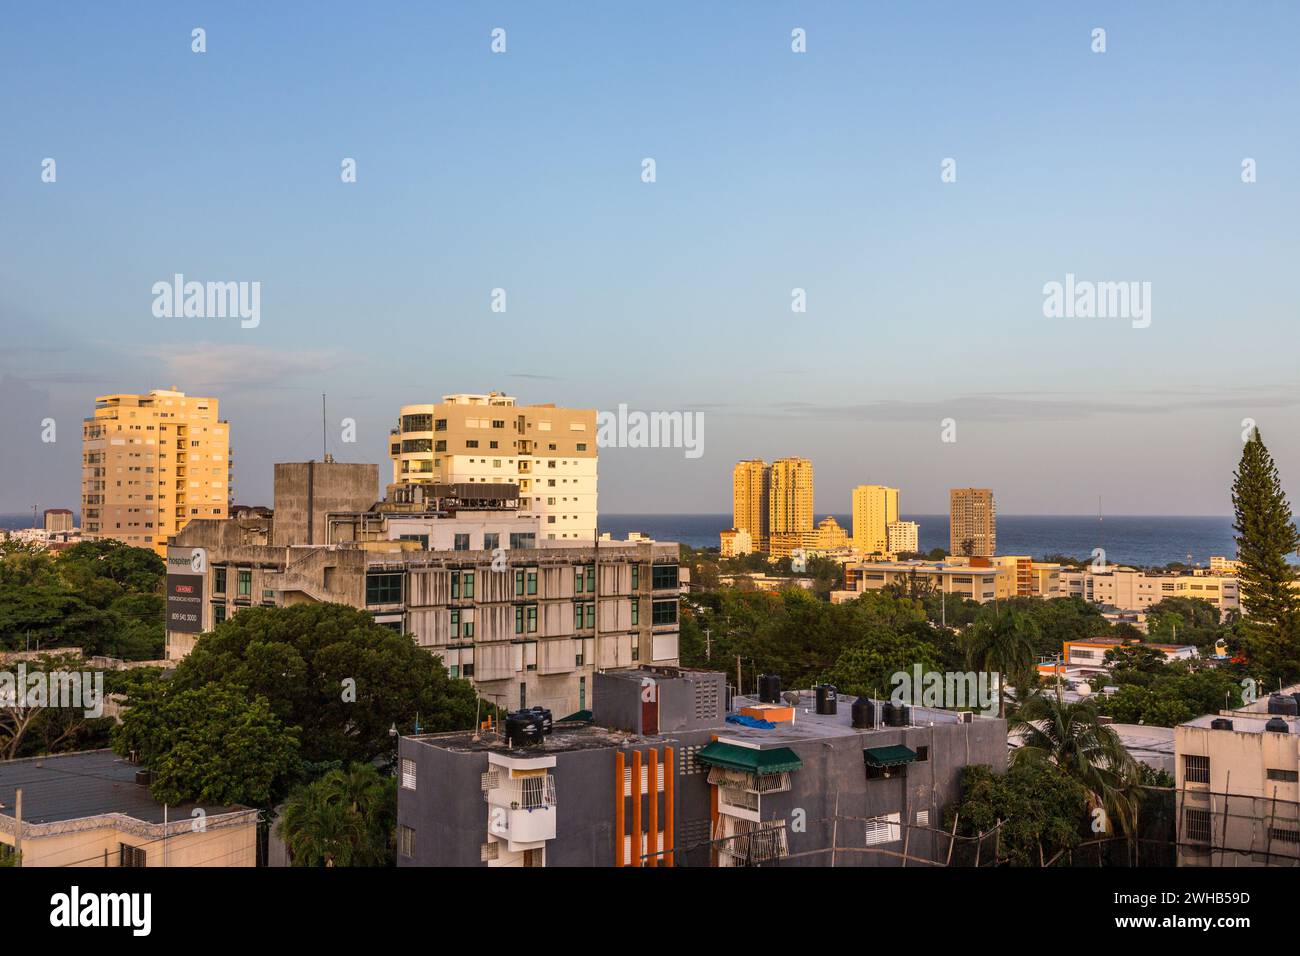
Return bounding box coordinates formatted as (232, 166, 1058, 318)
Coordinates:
(166, 463, 680, 714)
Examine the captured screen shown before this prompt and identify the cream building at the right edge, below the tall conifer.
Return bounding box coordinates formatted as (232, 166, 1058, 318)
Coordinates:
(1174, 687, 1300, 866)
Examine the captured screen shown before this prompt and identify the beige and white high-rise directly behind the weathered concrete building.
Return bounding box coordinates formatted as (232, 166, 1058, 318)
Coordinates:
(389, 392, 597, 541)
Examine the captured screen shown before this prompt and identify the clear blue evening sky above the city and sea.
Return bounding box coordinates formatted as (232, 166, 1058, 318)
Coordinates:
(0, 3, 1300, 514)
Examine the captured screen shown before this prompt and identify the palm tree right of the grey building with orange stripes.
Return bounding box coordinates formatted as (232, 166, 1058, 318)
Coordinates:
(1009, 693, 1141, 838)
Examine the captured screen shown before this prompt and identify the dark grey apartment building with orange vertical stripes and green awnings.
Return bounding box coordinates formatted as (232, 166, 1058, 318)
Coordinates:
(398, 666, 1006, 868)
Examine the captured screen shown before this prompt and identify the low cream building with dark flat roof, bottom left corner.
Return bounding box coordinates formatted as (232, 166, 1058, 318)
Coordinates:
(0, 750, 257, 868)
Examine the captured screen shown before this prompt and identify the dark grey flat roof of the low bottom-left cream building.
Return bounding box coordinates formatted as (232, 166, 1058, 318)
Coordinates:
(0, 750, 248, 826)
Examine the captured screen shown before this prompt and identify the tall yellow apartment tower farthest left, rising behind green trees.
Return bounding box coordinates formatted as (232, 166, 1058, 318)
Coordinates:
(82, 388, 230, 555)
